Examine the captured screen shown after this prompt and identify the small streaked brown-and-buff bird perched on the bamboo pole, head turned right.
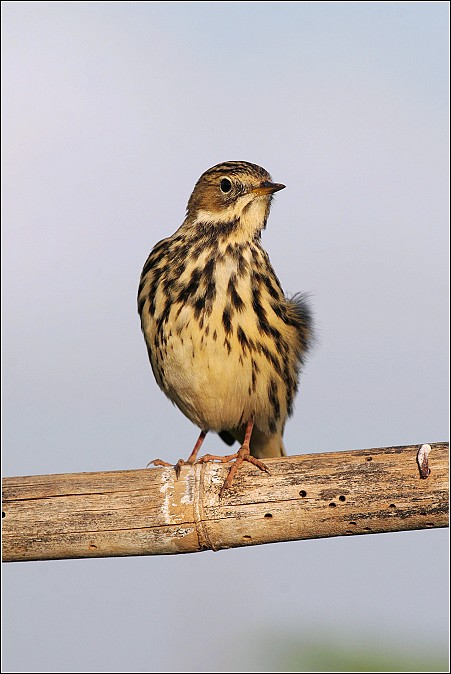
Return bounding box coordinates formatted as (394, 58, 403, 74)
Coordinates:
(138, 161, 313, 497)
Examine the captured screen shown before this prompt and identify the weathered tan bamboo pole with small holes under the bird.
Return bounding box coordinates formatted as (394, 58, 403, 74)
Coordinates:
(3, 443, 448, 561)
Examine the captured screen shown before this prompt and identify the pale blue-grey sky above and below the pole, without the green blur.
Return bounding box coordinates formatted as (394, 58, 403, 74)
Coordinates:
(2, 2, 449, 672)
